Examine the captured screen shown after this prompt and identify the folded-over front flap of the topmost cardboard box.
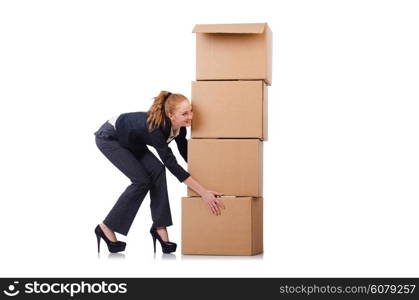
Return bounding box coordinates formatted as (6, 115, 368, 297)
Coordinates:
(192, 23, 266, 34)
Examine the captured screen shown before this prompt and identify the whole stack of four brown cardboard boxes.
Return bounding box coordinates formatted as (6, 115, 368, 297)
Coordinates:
(182, 23, 272, 255)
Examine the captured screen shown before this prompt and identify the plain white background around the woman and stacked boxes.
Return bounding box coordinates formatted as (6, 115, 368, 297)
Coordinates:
(0, 0, 419, 277)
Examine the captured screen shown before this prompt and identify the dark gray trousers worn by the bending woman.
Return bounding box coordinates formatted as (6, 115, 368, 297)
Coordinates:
(95, 122, 172, 235)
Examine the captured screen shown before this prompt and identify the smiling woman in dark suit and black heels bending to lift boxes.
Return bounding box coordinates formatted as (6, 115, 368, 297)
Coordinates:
(95, 91, 224, 253)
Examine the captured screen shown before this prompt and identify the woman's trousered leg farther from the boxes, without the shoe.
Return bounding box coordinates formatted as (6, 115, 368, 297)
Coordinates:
(96, 137, 151, 235)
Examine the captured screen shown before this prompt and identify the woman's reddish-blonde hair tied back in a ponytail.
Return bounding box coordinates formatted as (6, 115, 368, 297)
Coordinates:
(147, 91, 188, 131)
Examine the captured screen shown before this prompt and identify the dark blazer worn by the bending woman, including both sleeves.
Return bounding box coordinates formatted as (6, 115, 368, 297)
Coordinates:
(115, 112, 190, 182)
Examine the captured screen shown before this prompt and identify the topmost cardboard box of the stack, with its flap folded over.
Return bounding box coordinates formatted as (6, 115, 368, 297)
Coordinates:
(193, 23, 272, 85)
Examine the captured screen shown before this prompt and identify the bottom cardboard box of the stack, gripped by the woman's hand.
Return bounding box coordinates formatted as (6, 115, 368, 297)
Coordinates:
(182, 197, 263, 255)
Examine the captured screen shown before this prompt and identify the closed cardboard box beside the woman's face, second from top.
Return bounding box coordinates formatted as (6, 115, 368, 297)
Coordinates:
(191, 80, 268, 140)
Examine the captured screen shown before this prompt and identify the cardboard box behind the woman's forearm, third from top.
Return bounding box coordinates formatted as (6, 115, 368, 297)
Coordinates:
(188, 139, 263, 197)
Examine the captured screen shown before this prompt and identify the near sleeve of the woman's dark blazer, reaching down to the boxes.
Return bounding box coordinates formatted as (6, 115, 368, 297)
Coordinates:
(150, 128, 190, 182)
